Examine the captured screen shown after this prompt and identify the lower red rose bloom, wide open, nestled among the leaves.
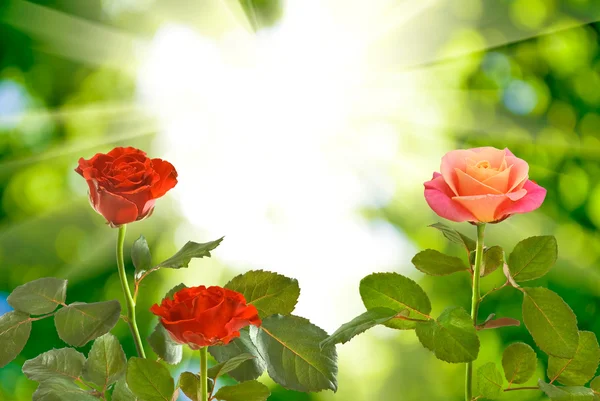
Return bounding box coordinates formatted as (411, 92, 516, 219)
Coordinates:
(150, 285, 261, 349)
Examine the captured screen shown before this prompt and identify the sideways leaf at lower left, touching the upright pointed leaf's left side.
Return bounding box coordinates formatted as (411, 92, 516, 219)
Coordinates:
(23, 348, 85, 382)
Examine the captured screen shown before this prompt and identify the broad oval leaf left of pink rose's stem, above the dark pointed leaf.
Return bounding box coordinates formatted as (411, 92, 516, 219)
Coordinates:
(360, 273, 431, 330)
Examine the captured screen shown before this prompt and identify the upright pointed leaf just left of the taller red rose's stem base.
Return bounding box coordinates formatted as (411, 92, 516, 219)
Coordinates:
(83, 333, 127, 388)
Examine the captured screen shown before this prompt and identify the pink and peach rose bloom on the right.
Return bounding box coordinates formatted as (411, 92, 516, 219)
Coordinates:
(425, 147, 546, 223)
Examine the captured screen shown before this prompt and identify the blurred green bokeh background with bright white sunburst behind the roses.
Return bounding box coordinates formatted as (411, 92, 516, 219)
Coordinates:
(0, 0, 600, 401)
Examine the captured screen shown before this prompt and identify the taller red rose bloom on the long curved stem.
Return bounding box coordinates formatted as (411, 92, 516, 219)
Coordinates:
(75, 148, 177, 227)
